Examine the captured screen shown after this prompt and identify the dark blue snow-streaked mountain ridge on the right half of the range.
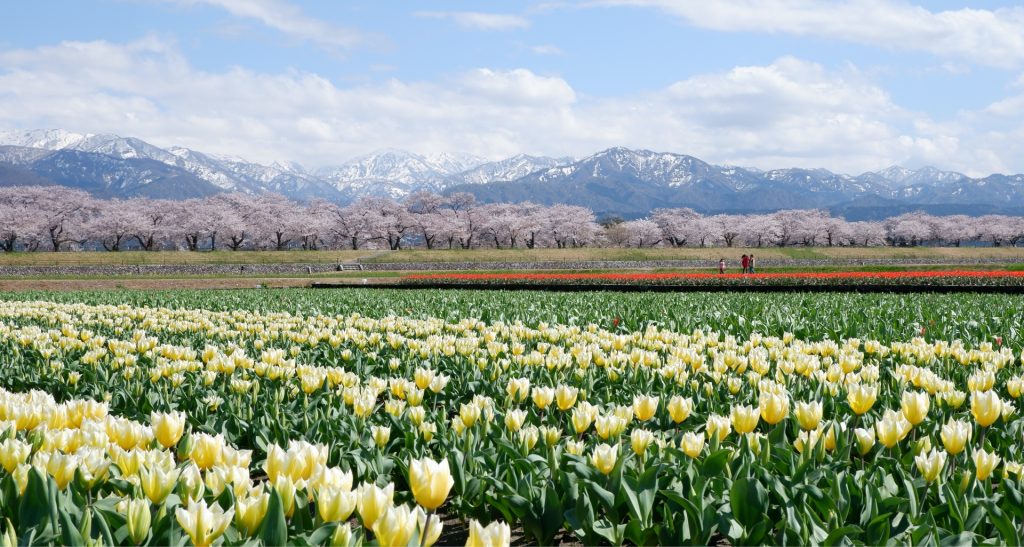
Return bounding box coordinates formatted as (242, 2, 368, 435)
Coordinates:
(449, 148, 1024, 217)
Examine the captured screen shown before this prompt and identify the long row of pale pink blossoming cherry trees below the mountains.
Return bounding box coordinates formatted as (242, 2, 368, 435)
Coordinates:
(0, 186, 1024, 252)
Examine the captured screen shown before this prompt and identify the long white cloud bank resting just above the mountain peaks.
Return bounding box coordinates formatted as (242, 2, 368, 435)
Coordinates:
(0, 38, 1024, 174)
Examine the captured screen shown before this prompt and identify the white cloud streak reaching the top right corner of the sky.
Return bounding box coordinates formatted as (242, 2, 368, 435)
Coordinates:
(598, 0, 1024, 68)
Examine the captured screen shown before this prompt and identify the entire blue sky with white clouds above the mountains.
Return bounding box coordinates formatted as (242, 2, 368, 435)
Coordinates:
(0, 0, 1024, 176)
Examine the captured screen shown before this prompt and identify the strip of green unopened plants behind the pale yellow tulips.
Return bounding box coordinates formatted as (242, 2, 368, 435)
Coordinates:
(2, 289, 1024, 348)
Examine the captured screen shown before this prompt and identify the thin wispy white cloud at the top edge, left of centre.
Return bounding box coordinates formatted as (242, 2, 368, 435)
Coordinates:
(165, 0, 375, 49)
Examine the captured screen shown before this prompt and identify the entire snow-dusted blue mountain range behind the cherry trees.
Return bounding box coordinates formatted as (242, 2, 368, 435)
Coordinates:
(0, 130, 1024, 220)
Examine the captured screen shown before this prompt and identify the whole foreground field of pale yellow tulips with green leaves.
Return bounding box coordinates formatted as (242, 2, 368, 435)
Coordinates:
(0, 289, 1024, 546)
